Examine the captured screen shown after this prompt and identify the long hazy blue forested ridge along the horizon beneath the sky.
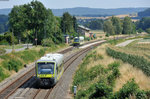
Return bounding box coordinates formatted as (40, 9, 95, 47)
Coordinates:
(0, 7, 147, 17)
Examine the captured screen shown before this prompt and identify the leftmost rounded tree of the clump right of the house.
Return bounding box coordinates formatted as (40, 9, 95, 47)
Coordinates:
(104, 20, 115, 35)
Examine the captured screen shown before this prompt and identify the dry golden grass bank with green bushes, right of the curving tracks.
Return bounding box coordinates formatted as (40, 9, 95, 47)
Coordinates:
(73, 36, 150, 99)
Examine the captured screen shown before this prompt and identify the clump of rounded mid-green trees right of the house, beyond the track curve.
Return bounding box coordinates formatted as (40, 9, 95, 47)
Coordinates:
(103, 16, 136, 36)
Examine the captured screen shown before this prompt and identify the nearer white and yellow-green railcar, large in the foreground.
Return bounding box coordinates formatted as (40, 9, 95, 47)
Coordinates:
(35, 53, 64, 87)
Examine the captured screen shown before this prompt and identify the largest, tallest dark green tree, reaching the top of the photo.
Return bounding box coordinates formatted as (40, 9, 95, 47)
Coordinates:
(9, 1, 47, 44)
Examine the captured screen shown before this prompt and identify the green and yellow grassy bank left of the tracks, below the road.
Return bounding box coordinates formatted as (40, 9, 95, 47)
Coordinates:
(0, 44, 67, 81)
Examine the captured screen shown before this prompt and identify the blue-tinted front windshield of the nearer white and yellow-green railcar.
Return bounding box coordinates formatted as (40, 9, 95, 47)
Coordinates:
(38, 62, 55, 74)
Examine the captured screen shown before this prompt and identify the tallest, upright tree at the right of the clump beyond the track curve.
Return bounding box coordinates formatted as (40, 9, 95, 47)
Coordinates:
(122, 17, 133, 34)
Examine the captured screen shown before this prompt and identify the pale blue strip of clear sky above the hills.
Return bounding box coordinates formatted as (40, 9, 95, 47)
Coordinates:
(0, 0, 150, 9)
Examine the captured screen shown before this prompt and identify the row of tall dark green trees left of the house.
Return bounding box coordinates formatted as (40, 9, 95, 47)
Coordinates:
(0, 1, 77, 45)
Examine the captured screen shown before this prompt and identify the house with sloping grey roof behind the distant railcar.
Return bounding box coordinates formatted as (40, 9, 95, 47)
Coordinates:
(78, 25, 90, 37)
